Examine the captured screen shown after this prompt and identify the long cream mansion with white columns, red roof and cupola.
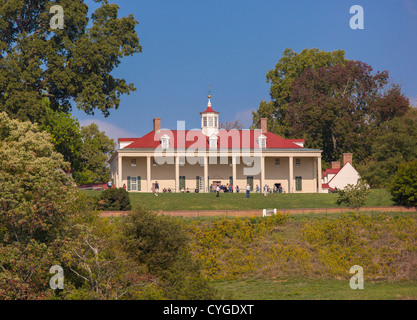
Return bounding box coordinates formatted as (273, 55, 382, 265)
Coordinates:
(109, 95, 322, 193)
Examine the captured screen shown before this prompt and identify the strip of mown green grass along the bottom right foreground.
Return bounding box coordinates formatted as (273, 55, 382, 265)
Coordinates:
(213, 277, 417, 300)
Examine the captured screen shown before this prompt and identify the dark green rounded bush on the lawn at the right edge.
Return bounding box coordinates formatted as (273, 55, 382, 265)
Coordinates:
(391, 159, 417, 207)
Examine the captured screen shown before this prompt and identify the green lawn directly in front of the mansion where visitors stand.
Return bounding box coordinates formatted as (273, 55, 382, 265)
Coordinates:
(87, 189, 393, 211)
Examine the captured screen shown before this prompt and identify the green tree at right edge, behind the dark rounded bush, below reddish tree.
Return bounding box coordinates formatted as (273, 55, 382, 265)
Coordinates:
(358, 107, 417, 188)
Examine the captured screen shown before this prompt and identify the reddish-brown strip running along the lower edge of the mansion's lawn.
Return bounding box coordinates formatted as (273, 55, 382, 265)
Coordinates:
(101, 207, 417, 217)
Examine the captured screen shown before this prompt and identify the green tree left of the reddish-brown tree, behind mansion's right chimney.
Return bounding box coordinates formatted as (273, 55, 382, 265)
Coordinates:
(252, 48, 346, 137)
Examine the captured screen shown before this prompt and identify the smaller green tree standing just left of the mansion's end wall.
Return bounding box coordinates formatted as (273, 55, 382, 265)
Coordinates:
(74, 123, 116, 185)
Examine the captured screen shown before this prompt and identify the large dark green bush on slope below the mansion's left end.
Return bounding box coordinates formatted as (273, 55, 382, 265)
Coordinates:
(123, 206, 216, 299)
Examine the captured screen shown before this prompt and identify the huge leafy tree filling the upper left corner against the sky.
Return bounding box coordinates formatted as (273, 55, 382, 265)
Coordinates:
(0, 0, 141, 123)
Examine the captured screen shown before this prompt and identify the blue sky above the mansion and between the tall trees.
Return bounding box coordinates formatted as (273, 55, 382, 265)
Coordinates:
(73, 0, 417, 142)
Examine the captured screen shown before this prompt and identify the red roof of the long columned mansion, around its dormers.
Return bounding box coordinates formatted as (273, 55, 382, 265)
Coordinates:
(119, 130, 303, 149)
